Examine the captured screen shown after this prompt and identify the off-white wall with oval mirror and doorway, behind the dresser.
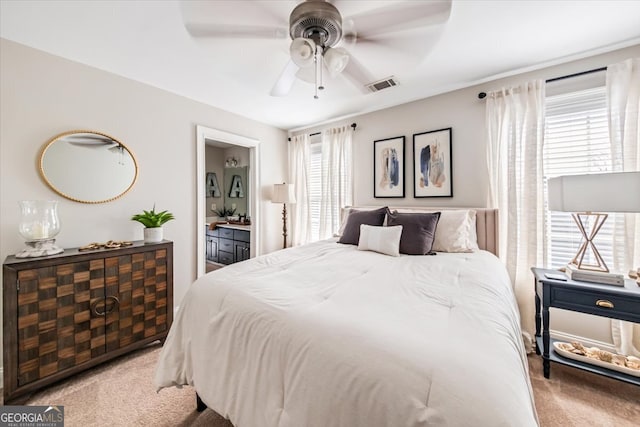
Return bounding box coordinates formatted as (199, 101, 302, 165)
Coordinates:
(0, 39, 287, 314)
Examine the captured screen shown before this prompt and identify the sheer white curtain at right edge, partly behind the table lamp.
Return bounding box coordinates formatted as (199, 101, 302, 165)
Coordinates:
(606, 58, 640, 357)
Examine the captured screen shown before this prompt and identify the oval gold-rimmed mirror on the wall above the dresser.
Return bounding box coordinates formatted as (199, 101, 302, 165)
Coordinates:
(40, 130, 138, 203)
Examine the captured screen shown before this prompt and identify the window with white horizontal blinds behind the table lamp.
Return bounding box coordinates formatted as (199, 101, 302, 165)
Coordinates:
(543, 79, 624, 268)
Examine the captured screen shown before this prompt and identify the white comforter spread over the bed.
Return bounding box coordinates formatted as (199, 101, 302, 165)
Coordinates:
(155, 240, 538, 427)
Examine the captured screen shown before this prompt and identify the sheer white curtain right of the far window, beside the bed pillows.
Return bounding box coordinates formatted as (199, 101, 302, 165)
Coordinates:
(319, 126, 353, 239)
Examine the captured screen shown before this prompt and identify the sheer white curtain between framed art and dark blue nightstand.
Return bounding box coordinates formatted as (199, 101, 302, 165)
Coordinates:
(486, 80, 545, 351)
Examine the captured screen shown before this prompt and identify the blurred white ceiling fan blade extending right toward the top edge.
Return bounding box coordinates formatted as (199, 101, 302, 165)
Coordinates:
(343, 0, 451, 41)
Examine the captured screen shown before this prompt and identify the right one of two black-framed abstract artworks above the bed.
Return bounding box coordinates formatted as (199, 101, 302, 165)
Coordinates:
(413, 128, 453, 198)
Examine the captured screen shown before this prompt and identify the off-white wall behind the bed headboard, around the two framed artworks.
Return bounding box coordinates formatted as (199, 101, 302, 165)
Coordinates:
(294, 45, 640, 350)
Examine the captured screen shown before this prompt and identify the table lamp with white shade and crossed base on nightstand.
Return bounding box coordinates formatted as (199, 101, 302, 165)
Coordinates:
(548, 171, 640, 273)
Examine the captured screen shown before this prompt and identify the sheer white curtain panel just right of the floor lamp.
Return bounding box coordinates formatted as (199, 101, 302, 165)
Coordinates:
(289, 134, 311, 246)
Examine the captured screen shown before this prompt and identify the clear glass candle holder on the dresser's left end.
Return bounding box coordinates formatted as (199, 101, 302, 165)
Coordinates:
(16, 200, 64, 258)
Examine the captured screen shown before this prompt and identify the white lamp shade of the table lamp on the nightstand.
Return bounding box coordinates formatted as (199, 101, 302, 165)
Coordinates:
(548, 172, 640, 212)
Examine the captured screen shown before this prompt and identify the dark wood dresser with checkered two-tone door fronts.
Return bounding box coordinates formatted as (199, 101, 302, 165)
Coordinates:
(3, 240, 173, 403)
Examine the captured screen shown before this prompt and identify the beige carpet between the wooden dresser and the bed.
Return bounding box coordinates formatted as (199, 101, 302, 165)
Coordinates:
(26, 345, 233, 427)
